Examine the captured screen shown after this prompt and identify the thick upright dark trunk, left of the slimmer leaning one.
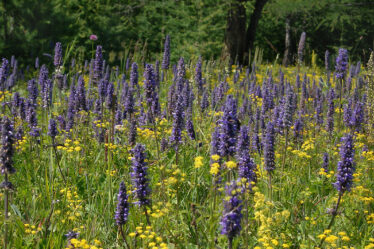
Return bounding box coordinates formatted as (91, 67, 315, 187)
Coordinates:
(225, 0, 246, 64)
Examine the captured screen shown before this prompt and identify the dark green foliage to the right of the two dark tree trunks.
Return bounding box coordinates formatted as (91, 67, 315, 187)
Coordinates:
(256, 0, 374, 64)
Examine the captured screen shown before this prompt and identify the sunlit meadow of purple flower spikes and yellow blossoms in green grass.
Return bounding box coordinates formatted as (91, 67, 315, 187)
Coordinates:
(0, 38, 374, 249)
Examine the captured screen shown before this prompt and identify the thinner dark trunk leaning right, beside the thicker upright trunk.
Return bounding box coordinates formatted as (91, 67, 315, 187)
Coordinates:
(243, 0, 268, 64)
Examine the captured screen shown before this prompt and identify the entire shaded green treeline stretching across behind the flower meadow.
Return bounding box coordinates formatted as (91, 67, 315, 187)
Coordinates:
(0, 0, 374, 64)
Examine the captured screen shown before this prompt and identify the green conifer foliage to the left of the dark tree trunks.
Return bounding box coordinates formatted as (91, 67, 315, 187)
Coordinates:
(0, 0, 226, 65)
